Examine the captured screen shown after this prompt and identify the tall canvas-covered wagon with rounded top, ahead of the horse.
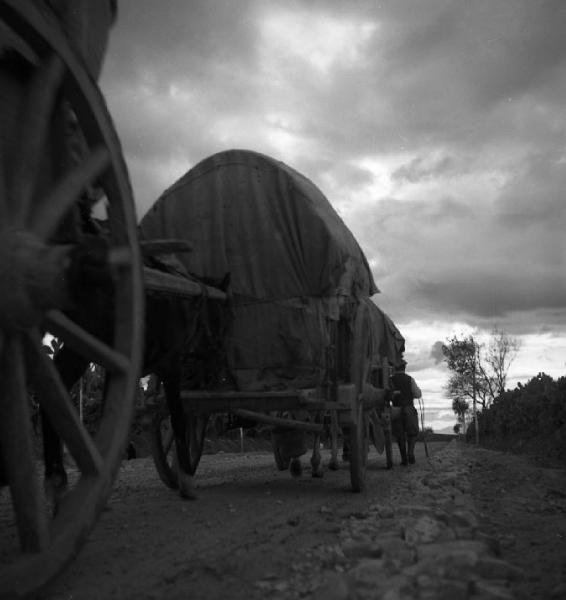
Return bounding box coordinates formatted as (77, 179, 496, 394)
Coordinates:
(140, 150, 402, 491)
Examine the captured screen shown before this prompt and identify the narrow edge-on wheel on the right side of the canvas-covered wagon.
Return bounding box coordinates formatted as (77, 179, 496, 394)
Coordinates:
(350, 303, 369, 492)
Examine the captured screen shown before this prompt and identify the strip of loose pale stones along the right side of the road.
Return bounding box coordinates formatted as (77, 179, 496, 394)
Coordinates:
(256, 441, 523, 600)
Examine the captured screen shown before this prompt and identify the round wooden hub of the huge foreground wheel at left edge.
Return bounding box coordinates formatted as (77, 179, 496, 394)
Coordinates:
(0, 231, 71, 330)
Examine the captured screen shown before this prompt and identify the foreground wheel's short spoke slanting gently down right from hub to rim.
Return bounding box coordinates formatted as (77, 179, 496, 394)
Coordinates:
(46, 310, 131, 373)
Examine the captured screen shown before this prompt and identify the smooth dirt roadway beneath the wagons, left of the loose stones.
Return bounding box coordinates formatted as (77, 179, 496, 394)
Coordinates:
(41, 443, 444, 600)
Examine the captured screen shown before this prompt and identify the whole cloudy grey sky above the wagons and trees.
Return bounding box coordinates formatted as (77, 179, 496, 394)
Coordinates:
(101, 0, 566, 430)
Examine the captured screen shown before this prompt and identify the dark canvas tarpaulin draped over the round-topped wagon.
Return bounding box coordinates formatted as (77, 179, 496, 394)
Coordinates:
(140, 150, 378, 389)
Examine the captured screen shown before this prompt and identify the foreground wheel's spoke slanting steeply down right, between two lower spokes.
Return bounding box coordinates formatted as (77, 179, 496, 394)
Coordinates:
(26, 335, 103, 475)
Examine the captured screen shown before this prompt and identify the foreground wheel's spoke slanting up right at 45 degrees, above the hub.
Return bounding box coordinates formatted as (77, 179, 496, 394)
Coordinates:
(30, 146, 110, 240)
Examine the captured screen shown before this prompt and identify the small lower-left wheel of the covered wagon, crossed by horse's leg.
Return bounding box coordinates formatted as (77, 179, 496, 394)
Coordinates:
(151, 410, 209, 489)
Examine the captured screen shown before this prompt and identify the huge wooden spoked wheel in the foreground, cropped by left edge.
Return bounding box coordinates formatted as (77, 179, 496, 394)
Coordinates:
(0, 0, 143, 598)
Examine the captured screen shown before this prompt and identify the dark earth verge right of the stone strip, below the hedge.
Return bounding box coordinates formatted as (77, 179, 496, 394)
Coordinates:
(467, 448, 566, 600)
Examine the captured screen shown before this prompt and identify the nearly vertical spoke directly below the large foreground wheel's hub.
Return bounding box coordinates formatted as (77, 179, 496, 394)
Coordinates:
(0, 336, 49, 552)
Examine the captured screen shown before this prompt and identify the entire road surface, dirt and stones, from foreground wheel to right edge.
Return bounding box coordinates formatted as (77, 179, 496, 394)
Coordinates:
(17, 442, 566, 600)
